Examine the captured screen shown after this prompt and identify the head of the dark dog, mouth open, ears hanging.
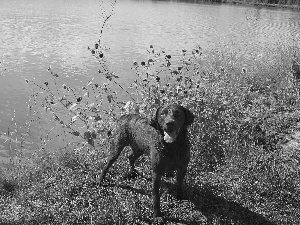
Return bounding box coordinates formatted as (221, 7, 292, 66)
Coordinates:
(150, 104, 194, 143)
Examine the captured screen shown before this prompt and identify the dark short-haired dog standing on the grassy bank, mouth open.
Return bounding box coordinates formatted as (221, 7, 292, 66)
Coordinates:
(100, 104, 194, 221)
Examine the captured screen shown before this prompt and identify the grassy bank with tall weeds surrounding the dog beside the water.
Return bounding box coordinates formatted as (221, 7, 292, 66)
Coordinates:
(0, 25, 300, 225)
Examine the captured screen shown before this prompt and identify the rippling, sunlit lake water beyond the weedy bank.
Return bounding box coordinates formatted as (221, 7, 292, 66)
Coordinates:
(0, 0, 300, 165)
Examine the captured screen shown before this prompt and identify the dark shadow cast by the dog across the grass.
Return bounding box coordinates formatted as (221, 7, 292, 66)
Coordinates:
(99, 168, 276, 225)
